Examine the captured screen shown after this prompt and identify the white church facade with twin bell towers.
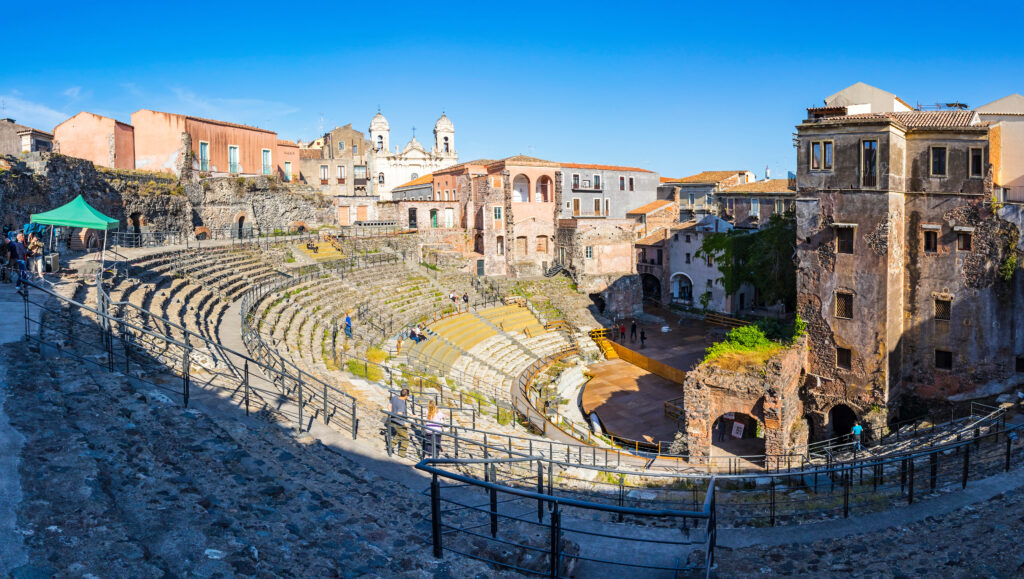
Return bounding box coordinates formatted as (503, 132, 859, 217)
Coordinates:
(370, 112, 459, 201)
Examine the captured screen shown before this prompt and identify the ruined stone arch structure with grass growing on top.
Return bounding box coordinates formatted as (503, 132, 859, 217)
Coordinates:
(683, 338, 807, 457)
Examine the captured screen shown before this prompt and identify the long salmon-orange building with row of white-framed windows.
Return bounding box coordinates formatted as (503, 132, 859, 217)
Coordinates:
(131, 109, 299, 177)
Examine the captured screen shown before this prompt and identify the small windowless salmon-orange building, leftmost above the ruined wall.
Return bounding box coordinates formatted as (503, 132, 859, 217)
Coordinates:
(53, 111, 135, 169)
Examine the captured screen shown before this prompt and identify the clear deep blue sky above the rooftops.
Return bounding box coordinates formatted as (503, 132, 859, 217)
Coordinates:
(6, 1, 1024, 176)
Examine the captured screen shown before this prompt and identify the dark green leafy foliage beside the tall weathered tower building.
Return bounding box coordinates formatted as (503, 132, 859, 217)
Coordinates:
(696, 211, 797, 311)
